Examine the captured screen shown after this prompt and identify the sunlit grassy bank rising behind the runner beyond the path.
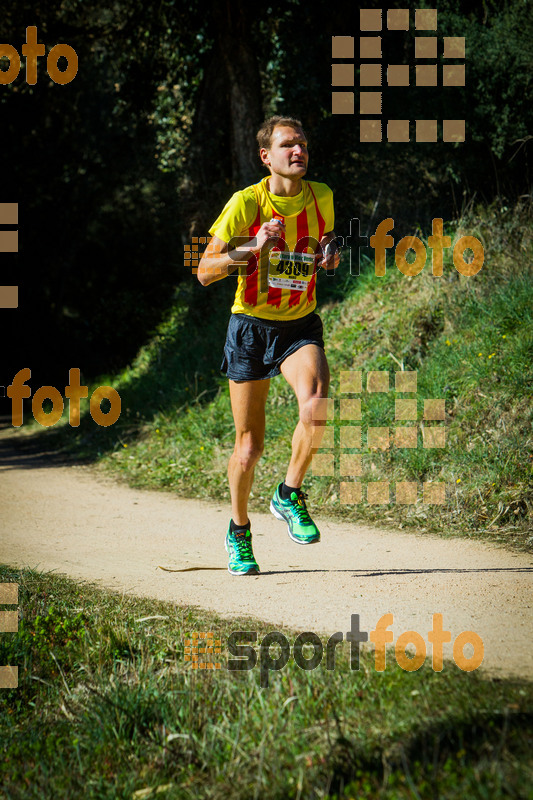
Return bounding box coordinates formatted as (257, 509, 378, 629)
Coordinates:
(16, 200, 533, 549)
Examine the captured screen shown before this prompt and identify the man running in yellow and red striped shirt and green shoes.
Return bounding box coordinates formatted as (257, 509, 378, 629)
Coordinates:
(198, 117, 340, 575)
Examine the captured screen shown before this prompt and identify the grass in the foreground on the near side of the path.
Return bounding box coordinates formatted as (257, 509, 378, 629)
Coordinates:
(0, 567, 533, 800)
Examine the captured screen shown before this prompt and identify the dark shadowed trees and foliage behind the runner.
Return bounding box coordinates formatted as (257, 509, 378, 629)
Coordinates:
(0, 0, 533, 386)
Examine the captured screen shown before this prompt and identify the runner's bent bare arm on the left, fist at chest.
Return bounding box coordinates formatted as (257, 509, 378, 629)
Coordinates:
(197, 220, 285, 286)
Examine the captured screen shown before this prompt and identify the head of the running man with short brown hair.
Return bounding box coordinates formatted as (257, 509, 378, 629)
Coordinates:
(257, 117, 309, 181)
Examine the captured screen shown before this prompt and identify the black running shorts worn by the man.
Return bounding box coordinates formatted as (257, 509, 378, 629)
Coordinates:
(220, 311, 324, 381)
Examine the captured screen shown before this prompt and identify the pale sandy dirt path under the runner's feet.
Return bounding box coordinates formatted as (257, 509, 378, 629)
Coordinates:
(0, 428, 533, 678)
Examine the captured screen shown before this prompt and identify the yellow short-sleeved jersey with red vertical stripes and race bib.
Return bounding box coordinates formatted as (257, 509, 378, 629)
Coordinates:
(209, 176, 335, 320)
